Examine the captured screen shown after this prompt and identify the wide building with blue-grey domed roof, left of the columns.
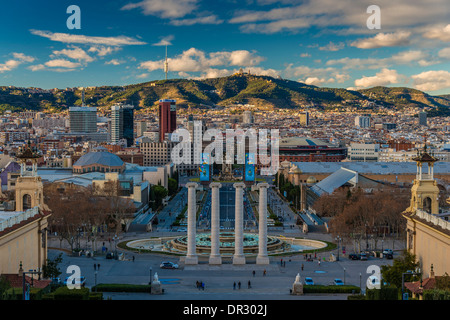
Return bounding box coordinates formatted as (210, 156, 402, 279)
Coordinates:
(73, 147, 125, 173)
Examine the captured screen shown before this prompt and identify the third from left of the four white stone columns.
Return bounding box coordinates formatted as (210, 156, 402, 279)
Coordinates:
(233, 182, 245, 264)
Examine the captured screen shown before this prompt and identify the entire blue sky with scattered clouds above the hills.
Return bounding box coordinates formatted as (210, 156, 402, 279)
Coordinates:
(0, 0, 450, 94)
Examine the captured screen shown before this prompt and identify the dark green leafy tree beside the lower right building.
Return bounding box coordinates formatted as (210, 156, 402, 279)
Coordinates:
(381, 250, 420, 288)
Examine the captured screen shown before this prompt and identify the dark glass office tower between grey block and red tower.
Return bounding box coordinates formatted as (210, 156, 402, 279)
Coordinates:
(111, 104, 134, 147)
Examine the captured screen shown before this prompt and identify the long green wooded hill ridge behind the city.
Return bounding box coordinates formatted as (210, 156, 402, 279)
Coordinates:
(0, 74, 450, 114)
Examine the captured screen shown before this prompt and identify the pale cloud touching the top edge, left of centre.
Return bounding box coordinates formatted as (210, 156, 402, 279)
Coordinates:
(122, 0, 197, 18)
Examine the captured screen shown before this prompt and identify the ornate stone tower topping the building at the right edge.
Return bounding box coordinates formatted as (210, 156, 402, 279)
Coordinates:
(407, 142, 439, 214)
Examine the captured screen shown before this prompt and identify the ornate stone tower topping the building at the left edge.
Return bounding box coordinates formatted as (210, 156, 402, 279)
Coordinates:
(16, 142, 44, 211)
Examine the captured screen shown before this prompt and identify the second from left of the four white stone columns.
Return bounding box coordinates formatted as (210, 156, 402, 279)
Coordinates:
(209, 182, 222, 264)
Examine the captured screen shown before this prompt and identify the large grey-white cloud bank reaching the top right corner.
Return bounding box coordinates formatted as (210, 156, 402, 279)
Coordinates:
(229, 0, 449, 34)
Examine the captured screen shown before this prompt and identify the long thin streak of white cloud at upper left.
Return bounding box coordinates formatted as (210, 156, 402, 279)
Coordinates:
(30, 29, 146, 46)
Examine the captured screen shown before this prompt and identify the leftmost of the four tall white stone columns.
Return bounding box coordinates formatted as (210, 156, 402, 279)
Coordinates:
(184, 182, 198, 265)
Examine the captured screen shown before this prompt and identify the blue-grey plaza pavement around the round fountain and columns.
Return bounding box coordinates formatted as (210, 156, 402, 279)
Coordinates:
(45, 179, 404, 300)
